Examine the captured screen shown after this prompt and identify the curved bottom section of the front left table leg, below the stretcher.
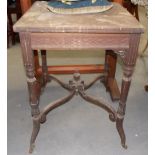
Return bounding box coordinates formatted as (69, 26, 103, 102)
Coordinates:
(29, 117, 40, 153)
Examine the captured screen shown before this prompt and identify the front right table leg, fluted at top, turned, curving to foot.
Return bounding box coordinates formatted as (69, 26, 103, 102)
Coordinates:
(116, 34, 140, 148)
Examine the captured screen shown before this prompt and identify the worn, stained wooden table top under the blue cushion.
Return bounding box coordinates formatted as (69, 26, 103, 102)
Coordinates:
(13, 1, 143, 33)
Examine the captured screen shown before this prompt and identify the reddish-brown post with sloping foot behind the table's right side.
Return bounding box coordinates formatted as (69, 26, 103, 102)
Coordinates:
(105, 50, 120, 101)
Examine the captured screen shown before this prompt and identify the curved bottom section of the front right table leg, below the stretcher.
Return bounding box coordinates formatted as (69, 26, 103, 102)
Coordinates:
(116, 118, 127, 149)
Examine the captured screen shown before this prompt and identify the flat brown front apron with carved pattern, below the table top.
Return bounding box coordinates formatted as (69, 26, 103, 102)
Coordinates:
(31, 33, 130, 50)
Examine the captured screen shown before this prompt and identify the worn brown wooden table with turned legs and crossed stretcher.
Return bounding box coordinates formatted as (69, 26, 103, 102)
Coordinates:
(14, 2, 143, 153)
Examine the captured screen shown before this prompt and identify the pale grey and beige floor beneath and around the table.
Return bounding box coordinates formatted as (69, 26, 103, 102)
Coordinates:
(8, 6, 148, 155)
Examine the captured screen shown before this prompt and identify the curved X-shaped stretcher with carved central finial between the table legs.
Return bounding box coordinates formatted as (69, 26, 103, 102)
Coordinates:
(39, 72, 117, 123)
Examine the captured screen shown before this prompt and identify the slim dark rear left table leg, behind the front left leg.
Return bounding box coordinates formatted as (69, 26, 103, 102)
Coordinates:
(41, 50, 49, 87)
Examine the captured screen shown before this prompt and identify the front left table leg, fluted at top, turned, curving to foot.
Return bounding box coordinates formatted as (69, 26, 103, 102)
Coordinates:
(20, 32, 40, 153)
